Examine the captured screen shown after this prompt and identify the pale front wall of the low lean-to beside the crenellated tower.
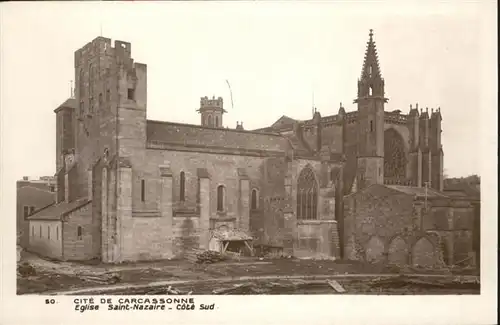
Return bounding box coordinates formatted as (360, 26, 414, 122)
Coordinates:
(29, 220, 63, 259)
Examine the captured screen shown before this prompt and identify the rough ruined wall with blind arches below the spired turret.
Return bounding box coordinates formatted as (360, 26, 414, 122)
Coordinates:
(344, 185, 443, 266)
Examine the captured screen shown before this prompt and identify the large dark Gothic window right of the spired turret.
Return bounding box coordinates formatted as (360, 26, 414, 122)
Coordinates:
(384, 128, 406, 178)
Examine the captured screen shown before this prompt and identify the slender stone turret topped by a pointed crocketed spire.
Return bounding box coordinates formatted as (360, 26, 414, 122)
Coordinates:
(354, 29, 388, 189)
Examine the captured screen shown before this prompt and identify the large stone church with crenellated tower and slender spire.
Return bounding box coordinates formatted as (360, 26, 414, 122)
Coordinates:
(29, 31, 476, 264)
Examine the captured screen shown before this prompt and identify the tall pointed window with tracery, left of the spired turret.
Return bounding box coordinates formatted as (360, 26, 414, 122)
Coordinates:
(297, 167, 318, 220)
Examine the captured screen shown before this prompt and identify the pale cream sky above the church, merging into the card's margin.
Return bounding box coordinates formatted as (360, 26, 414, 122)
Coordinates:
(0, 1, 496, 179)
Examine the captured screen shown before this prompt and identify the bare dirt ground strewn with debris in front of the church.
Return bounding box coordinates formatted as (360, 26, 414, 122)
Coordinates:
(17, 253, 479, 294)
